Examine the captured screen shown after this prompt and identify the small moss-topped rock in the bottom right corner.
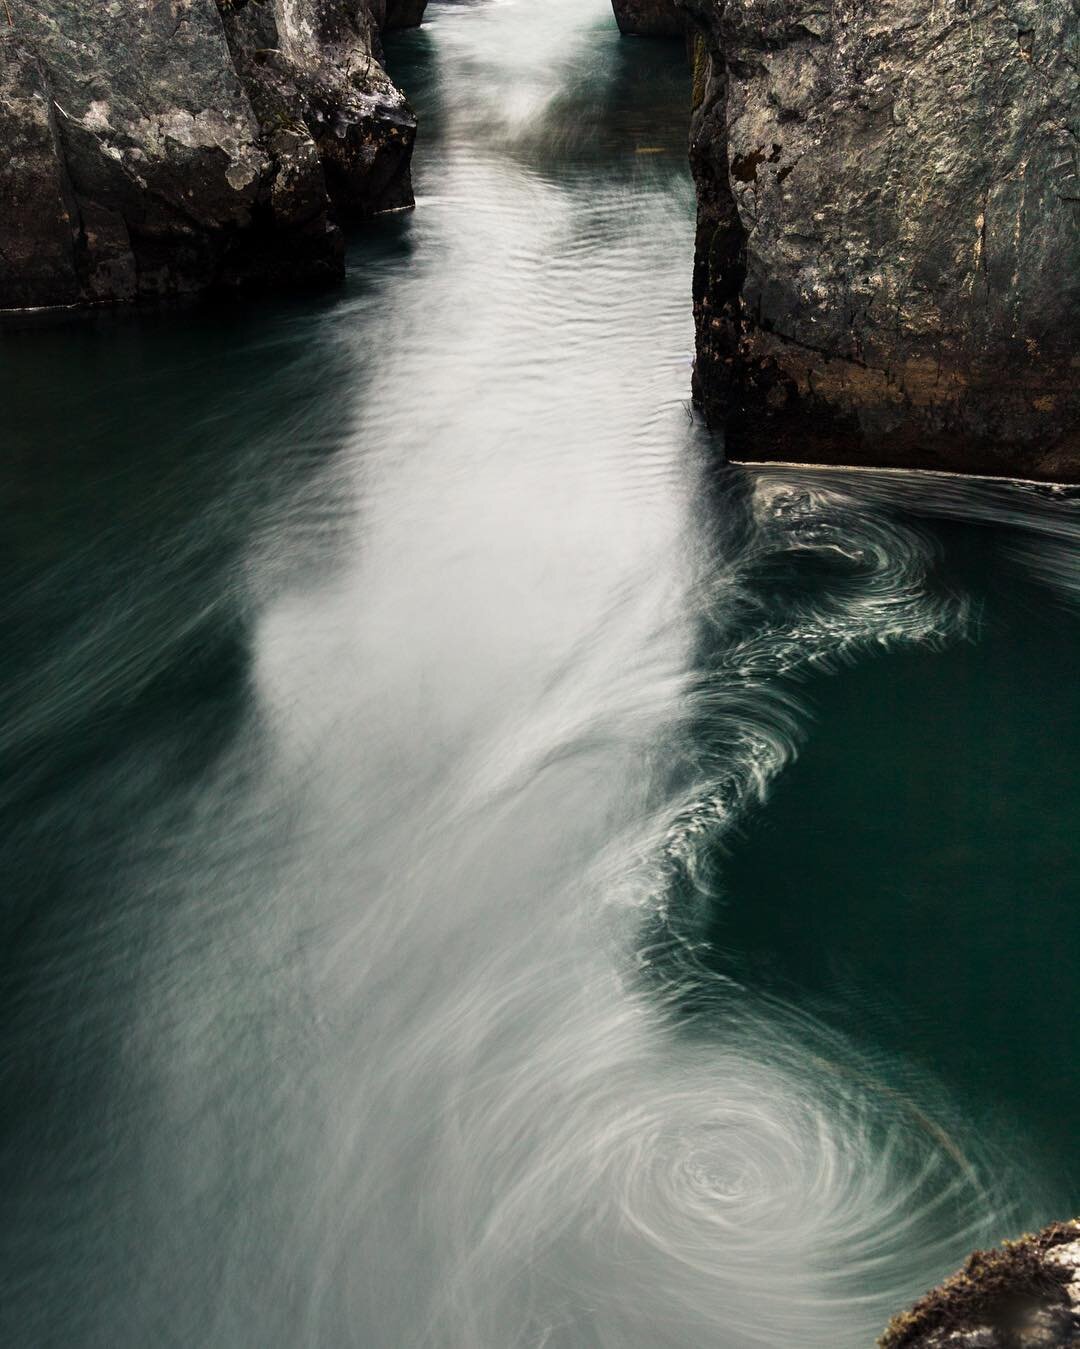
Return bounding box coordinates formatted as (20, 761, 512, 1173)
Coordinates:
(878, 1222, 1080, 1349)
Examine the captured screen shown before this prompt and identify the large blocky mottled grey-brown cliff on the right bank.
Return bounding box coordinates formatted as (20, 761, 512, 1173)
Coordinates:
(680, 0, 1080, 479)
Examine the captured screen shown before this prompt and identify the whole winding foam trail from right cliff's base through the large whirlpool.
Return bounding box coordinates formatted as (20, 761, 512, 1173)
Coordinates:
(366, 473, 1040, 1349)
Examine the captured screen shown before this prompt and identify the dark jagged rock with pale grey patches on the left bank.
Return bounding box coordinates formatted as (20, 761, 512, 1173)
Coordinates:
(0, 0, 423, 309)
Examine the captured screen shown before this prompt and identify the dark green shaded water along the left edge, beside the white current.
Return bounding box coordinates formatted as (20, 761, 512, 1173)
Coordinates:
(0, 292, 380, 1344)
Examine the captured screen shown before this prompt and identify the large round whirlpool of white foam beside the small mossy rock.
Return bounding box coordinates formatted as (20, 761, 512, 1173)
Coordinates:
(409, 989, 1011, 1349)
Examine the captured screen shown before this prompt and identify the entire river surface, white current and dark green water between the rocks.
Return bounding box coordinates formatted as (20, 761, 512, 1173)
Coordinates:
(0, 0, 1080, 1349)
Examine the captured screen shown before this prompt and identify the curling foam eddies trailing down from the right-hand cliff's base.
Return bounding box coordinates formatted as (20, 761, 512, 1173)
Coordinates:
(651, 475, 972, 909)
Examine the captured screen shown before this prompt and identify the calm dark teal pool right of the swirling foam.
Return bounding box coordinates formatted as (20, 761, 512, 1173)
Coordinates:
(709, 507, 1080, 1192)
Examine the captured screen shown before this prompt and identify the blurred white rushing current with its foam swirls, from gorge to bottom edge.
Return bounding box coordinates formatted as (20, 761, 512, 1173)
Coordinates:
(5, 0, 1076, 1349)
